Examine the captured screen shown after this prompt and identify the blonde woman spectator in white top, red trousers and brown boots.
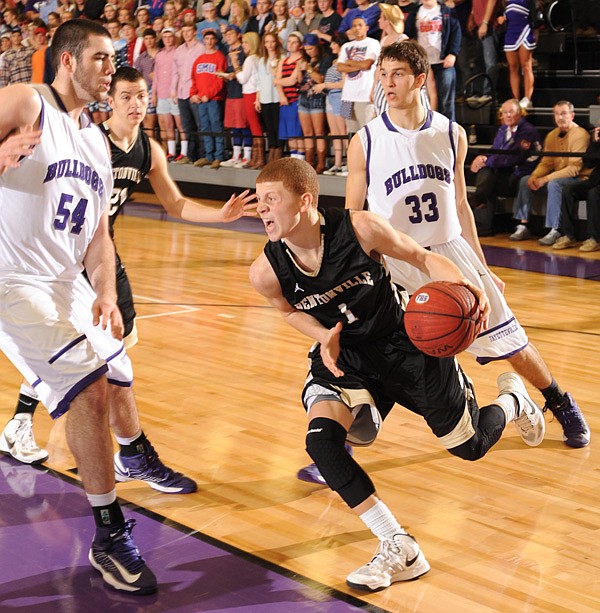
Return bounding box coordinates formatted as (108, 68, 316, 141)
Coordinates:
(231, 32, 265, 168)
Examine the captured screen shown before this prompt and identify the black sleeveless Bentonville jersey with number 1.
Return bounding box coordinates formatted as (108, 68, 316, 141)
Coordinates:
(264, 208, 403, 345)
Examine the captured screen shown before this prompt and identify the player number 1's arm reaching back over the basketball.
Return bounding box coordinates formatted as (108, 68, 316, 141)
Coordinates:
(352, 211, 490, 320)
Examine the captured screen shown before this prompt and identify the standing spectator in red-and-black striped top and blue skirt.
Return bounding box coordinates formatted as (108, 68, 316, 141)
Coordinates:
(275, 32, 304, 160)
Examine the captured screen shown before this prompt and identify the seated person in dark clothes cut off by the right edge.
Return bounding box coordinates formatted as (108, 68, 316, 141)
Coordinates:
(552, 128, 600, 252)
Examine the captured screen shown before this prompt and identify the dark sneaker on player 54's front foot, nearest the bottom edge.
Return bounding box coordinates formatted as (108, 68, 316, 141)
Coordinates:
(88, 519, 158, 594)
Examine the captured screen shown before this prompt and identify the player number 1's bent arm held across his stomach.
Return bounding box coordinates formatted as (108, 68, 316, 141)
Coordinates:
(250, 253, 344, 377)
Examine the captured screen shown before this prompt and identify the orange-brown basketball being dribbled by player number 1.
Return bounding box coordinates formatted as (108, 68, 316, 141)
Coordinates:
(404, 281, 482, 358)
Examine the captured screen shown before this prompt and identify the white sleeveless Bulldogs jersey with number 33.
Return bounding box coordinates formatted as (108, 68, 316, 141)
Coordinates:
(358, 111, 461, 247)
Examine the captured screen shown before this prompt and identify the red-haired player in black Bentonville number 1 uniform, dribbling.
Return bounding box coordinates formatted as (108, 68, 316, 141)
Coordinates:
(250, 158, 544, 590)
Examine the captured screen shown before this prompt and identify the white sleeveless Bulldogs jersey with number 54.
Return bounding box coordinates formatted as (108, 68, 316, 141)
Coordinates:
(0, 86, 113, 280)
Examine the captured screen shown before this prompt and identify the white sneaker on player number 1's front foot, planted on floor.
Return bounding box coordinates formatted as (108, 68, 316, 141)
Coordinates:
(346, 534, 431, 591)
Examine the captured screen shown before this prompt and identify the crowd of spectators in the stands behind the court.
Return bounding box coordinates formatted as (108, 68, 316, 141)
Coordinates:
(0, 0, 600, 241)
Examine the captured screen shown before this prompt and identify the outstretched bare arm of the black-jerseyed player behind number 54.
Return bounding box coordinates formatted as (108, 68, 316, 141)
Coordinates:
(148, 139, 256, 223)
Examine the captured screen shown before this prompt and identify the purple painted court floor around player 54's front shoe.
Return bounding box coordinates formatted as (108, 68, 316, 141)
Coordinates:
(0, 458, 384, 613)
